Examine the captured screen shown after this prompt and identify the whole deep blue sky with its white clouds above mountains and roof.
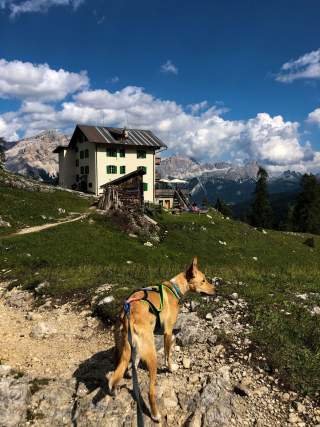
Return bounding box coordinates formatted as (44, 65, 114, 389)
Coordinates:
(0, 0, 320, 171)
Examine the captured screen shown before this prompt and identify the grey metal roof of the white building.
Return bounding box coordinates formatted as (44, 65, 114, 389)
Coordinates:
(70, 125, 167, 149)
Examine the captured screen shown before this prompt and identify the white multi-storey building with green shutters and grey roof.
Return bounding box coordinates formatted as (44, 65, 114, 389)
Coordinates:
(54, 125, 167, 203)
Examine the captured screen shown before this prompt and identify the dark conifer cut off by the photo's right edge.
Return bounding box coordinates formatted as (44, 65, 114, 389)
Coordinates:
(293, 174, 320, 234)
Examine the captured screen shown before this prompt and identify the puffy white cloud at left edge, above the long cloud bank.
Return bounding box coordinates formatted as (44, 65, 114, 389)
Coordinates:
(0, 59, 89, 101)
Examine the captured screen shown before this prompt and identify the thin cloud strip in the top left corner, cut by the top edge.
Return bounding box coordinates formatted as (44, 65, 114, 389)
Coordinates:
(0, 0, 85, 17)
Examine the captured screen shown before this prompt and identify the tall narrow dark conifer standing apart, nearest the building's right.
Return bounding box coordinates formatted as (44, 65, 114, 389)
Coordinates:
(250, 167, 273, 228)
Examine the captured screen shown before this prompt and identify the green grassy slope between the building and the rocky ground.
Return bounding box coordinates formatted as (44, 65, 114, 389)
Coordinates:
(0, 183, 320, 393)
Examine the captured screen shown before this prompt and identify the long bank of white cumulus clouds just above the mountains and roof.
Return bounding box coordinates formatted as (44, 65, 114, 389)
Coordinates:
(0, 57, 320, 172)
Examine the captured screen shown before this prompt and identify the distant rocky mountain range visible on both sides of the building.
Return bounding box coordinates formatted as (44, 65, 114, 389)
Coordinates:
(1, 130, 318, 205)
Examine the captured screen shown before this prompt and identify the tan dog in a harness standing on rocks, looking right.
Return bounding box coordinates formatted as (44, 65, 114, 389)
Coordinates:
(109, 257, 215, 421)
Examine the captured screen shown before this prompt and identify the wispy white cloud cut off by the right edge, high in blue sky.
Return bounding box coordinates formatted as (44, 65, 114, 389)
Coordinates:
(276, 49, 320, 83)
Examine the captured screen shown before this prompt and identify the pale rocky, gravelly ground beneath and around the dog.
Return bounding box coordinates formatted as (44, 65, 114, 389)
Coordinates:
(0, 283, 320, 427)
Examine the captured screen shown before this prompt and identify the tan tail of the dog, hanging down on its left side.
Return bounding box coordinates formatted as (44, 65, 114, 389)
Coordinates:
(109, 311, 131, 392)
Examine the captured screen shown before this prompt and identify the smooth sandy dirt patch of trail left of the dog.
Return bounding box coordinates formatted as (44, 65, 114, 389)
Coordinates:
(0, 286, 112, 378)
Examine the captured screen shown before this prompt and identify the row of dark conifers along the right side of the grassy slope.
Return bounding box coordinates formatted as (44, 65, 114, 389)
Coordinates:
(215, 167, 320, 234)
